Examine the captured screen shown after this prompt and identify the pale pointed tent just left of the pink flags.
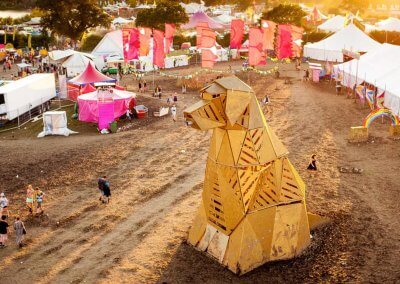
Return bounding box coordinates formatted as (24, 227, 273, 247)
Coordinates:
(92, 30, 124, 58)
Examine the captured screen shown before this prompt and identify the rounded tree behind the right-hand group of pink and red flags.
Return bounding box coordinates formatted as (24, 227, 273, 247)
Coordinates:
(261, 4, 307, 26)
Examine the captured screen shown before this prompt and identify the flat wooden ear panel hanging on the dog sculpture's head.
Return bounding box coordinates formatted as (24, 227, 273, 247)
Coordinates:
(225, 90, 252, 125)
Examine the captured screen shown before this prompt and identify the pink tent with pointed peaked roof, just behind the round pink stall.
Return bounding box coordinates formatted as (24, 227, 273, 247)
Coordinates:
(67, 62, 117, 101)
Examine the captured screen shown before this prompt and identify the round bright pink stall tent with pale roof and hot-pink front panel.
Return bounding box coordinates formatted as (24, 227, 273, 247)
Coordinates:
(78, 89, 136, 129)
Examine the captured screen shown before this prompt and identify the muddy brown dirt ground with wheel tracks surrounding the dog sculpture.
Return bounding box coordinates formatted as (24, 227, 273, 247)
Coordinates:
(0, 63, 400, 283)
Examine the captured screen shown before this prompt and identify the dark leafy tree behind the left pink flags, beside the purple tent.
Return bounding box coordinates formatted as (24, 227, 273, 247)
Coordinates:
(136, 1, 189, 30)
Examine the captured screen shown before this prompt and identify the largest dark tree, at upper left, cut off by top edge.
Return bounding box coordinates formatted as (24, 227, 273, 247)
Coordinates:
(36, 0, 111, 41)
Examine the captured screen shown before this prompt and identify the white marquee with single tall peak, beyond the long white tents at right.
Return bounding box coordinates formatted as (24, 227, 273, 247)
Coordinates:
(304, 24, 381, 62)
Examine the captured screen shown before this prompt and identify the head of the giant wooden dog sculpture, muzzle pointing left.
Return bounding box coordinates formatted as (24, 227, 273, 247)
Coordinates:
(184, 76, 259, 130)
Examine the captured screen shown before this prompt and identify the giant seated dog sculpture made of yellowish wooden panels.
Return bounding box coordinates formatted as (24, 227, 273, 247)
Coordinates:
(184, 77, 318, 274)
